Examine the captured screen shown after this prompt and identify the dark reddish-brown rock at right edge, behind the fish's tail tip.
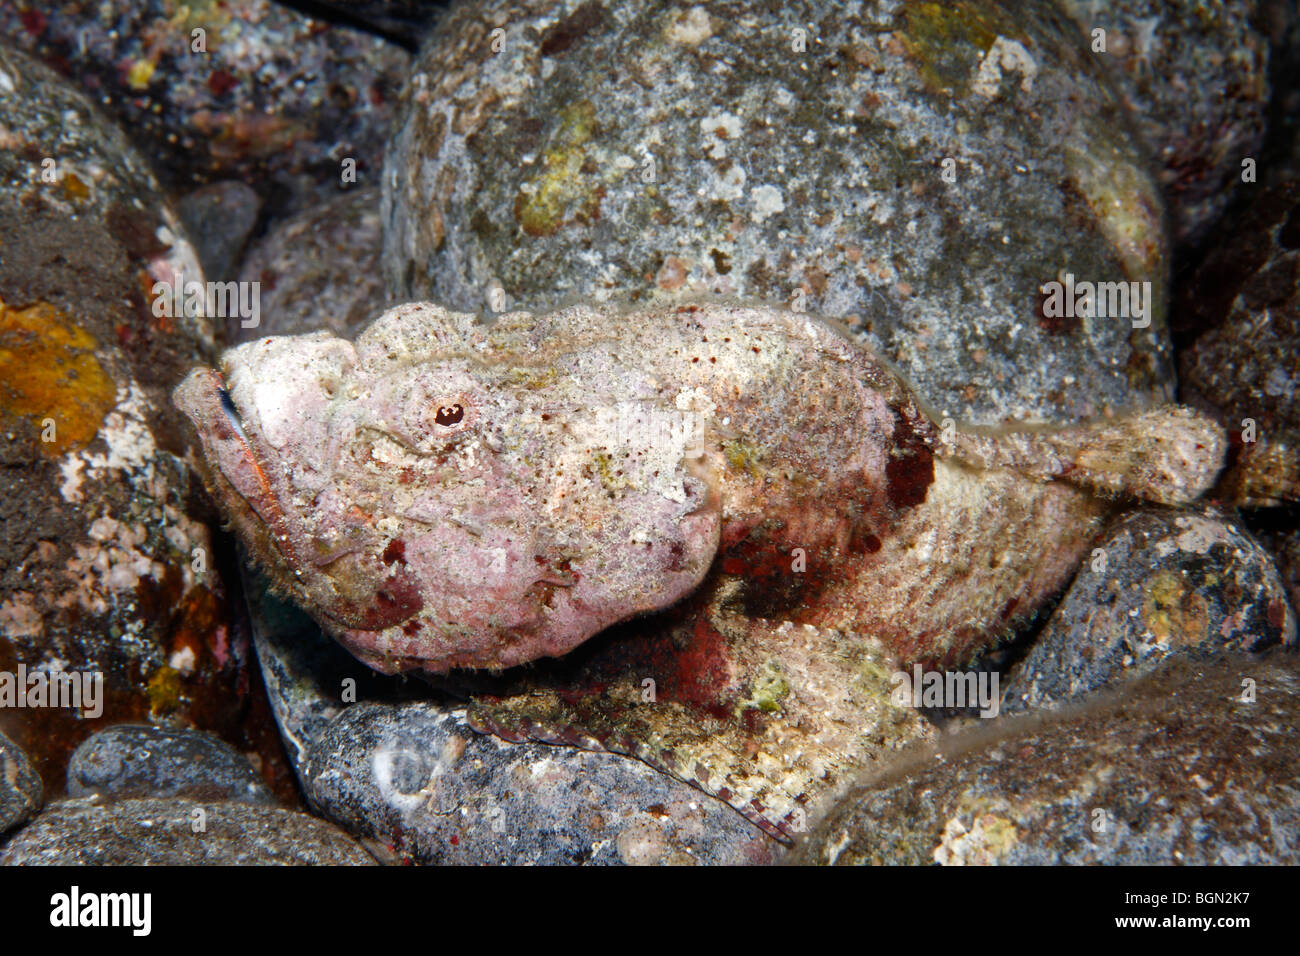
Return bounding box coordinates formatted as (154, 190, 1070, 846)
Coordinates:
(1179, 177, 1300, 505)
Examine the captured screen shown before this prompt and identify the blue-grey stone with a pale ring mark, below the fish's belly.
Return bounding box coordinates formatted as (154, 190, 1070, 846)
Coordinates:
(303, 702, 780, 865)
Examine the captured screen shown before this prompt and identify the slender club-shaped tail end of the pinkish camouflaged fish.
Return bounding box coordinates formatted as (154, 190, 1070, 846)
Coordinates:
(940, 406, 1227, 505)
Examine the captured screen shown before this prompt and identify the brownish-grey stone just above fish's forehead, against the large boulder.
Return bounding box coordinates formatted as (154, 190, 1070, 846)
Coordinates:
(235, 186, 397, 342)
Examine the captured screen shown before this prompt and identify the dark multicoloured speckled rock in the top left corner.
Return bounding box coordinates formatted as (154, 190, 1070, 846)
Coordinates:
(0, 0, 410, 217)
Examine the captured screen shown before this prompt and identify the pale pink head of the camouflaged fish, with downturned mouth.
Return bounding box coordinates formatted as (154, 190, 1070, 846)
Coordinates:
(174, 303, 722, 672)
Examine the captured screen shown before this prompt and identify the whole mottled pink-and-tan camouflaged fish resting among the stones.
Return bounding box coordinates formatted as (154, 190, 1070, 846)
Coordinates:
(176, 303, 1225, 835)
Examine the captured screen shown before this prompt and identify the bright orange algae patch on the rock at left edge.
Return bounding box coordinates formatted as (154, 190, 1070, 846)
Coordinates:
(0, 302, 117, 458)
